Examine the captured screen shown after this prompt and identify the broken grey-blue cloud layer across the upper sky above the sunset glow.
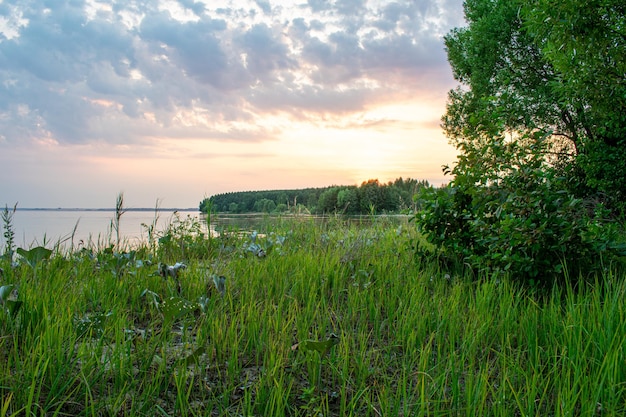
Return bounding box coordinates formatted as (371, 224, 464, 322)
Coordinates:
(0, 0, 462, 146)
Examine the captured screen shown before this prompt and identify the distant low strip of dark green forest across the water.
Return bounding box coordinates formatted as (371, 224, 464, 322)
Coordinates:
(200, 178, 430, 214)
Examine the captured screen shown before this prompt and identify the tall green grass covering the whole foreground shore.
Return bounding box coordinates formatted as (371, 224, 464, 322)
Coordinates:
(0, 213, 626, 417)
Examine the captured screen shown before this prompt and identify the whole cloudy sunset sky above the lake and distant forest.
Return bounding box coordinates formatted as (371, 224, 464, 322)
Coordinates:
(0, 0, 465, 208)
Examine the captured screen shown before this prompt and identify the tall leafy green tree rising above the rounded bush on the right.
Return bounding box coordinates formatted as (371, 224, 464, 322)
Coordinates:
(443, 0, 626, 201)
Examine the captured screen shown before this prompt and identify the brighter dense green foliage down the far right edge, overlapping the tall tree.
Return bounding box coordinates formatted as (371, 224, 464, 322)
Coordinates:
(523, 0, 626, 210)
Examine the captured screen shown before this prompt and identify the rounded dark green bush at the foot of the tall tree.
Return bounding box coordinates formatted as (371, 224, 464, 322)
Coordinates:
(415, 136, 626, 285)
